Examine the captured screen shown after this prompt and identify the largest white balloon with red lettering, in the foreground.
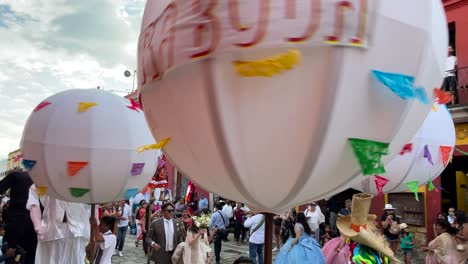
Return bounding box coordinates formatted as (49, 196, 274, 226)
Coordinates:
(138, 0, 447, 212)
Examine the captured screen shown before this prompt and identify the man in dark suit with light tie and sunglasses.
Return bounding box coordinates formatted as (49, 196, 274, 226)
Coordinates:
(146, 203, 186, 264)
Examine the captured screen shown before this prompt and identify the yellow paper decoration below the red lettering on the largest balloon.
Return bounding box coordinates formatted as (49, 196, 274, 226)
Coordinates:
(232, 50, 302, 77)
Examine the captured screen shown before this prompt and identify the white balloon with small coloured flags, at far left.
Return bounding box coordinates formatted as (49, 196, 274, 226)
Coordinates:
(21, 89, 161, 203)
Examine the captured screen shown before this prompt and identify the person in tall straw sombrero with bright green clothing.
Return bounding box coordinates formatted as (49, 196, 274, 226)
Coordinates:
(337, 193, 400, 264)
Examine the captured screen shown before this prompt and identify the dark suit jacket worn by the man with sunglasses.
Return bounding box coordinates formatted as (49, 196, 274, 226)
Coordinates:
(146, 217, 186, 264)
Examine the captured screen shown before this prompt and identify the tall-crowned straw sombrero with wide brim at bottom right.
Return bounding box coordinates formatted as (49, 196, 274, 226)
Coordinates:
(336, 193, 400, 263)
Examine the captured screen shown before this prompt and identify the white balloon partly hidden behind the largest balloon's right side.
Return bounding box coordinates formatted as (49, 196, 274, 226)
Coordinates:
(350, 105, 455, 194)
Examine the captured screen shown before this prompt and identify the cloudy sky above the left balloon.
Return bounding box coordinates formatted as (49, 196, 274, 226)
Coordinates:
(0, 0, 146, 159)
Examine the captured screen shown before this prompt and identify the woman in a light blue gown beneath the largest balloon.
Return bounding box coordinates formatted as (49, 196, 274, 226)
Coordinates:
(275, 212, 325, 264)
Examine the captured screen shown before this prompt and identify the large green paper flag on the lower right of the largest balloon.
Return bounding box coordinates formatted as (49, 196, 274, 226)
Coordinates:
(348, 138, 389, 175)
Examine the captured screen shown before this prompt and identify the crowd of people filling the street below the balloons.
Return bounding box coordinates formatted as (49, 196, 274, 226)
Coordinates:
(0, 172, 468, 264)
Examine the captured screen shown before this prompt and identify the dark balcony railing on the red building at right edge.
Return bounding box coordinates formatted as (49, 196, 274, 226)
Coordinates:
(445, 67, 468, 107)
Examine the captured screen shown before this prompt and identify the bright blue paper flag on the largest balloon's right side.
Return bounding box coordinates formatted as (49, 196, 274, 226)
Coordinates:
(372, 70, 415, 100)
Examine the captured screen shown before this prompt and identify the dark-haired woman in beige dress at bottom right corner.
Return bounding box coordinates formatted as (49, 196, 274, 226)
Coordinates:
(423, 219, 468, 264)
